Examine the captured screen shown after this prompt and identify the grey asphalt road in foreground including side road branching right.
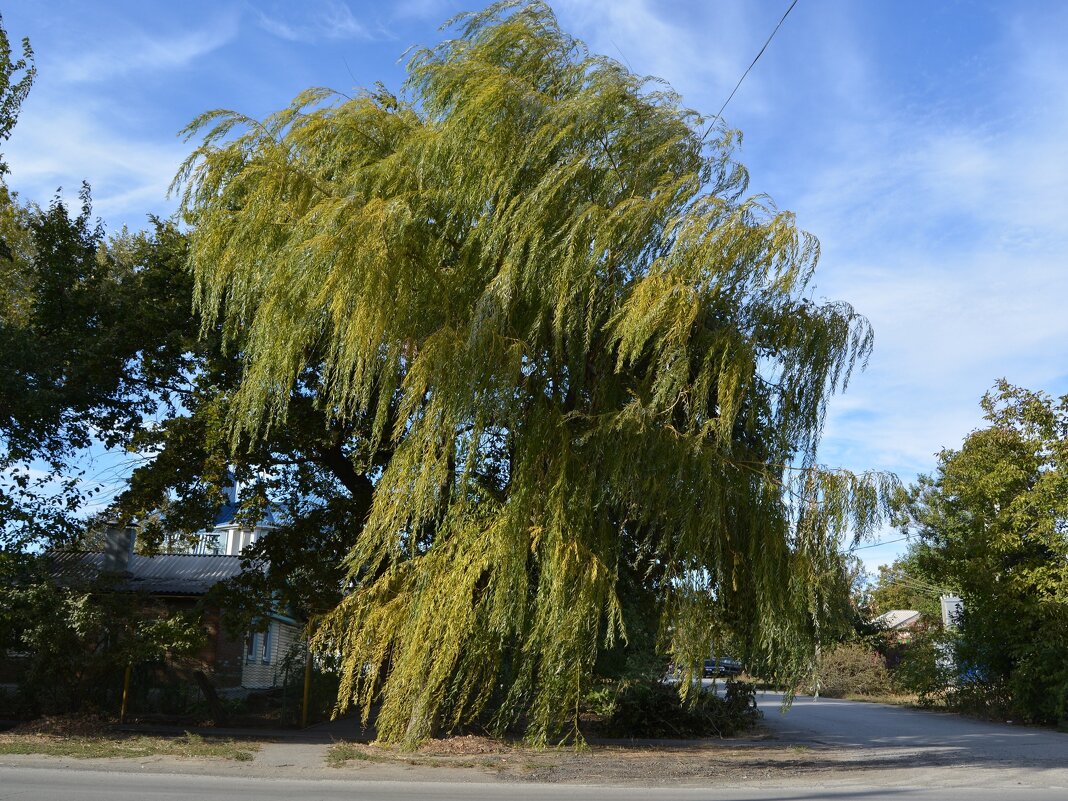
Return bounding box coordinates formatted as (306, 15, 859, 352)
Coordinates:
(0, 693, 1068, 801)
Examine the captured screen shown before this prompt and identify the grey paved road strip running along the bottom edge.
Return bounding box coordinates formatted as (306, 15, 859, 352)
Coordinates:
(0, 768, 1066, 801)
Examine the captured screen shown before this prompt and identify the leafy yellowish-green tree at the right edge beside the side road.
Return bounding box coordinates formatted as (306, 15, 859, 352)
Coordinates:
(910, 381, 1068, 722)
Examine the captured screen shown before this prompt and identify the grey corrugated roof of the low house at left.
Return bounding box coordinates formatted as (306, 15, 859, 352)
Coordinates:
(52, 552, 241, 595)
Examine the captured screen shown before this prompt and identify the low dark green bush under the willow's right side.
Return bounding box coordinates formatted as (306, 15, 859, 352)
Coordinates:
(590, 679, 761, 738)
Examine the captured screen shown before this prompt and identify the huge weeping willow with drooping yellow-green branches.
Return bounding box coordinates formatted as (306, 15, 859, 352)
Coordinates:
(177, 2, 885, 743)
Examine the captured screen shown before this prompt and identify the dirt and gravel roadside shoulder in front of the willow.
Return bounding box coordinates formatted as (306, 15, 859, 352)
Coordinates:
(0, 707, 1068, 789)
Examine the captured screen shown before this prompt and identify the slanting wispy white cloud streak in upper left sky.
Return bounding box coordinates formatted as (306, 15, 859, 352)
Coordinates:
(58, 15, 237, 82)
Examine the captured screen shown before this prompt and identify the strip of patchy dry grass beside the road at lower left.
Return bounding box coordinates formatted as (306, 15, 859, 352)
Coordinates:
(0, 734, 260, 761)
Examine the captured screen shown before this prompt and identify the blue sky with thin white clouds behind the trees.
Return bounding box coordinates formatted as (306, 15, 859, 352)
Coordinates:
(3, 0, 1068, 567)
